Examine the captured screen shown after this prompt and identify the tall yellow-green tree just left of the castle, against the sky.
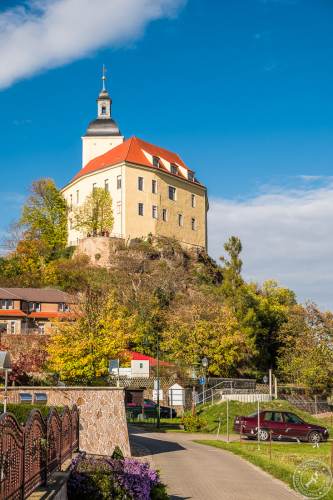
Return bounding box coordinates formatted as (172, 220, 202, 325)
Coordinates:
(19, 179, 67, 258)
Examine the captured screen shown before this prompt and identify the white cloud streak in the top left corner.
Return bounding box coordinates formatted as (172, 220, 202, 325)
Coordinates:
(0, 0, 186, 88)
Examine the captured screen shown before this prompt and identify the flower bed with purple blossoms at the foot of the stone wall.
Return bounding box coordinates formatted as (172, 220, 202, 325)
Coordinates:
(67, 451, 169, 500)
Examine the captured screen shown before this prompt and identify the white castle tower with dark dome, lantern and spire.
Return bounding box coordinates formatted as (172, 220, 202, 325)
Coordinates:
(82, 66, 124, 167)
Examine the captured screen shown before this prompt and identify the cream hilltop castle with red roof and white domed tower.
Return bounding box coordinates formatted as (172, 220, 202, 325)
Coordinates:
(62, 67, 208, 249)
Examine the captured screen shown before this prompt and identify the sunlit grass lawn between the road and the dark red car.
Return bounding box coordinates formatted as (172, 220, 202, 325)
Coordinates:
(195, 440, 333, 500)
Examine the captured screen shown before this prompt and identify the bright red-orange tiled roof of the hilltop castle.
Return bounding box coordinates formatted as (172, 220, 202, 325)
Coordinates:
(73, 137, 192, 181)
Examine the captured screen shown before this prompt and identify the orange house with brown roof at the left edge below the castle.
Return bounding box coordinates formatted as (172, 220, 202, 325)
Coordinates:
(0, 288, 74, 335)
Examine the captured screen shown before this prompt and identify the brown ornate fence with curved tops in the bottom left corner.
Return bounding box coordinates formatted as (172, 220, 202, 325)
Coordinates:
(0, 406, 79, 500)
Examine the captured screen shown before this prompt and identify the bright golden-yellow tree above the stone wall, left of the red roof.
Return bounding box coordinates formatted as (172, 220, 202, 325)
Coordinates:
(48, 290, 133, 384)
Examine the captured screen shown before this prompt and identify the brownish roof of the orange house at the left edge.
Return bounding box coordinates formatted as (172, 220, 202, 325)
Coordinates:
(0, 288, 74, 304)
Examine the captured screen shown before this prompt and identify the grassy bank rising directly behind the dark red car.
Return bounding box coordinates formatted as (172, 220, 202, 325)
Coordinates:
(193, 400, 333, 435)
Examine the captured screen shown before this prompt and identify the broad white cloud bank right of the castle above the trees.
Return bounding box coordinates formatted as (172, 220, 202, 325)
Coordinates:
(209, 184, 333, 309)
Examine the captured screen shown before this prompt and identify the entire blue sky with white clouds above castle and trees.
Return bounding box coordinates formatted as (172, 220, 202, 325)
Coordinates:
(0, 0, 333, 307)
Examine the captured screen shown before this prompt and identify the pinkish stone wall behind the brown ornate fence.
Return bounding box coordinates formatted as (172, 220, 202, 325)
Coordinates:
(2, 387, 130, 456)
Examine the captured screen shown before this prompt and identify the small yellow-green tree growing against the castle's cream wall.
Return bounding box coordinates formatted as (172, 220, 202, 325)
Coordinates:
(75, 188, 114, 235)
